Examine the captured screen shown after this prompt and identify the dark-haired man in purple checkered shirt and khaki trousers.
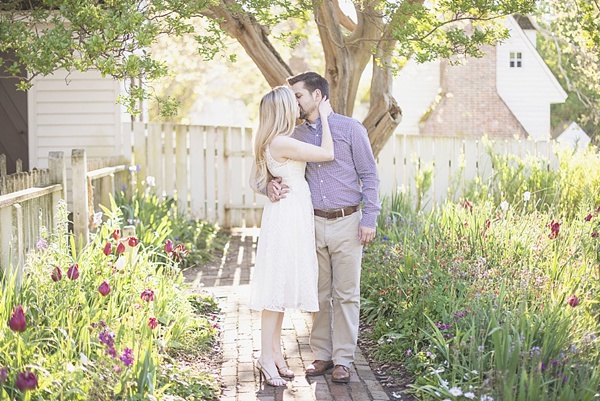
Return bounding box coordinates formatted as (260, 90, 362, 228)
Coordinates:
(267, 72, 381, 383)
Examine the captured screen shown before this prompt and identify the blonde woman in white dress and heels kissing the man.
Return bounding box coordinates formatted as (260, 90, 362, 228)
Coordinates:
(250, 86, 334, 387)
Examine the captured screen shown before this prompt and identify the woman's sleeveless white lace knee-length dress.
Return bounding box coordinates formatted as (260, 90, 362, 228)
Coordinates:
(249, 146, 319, 312)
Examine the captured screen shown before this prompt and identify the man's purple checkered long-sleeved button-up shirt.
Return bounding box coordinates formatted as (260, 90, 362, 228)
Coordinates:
(292, 113, 381, 228)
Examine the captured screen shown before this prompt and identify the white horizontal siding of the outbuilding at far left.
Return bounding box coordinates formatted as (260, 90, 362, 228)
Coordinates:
(28, 70, 131, 168)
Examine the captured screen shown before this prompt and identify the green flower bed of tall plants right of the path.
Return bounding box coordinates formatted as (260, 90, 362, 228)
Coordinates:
(361, 148, 600, 400)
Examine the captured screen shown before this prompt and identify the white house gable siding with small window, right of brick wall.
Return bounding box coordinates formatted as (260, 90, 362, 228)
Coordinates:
(496, 17, 567, 140)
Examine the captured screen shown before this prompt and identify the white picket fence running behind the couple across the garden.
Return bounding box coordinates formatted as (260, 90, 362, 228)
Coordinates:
(133, 123, 557, 228)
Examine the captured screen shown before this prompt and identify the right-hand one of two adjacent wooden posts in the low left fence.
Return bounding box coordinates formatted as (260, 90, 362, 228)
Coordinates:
(71, 149, 90, 249)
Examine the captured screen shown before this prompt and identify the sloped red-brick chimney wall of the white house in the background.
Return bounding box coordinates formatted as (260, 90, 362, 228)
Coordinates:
(420, 46, 527, 138)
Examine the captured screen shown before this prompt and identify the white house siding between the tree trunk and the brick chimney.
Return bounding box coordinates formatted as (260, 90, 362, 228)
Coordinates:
(393, 59, 440, 135)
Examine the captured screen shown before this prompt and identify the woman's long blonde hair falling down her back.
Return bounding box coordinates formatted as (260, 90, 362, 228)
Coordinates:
(254, 86, 298, 190)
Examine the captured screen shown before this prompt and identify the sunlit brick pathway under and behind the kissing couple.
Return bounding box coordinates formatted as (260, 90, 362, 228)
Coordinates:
(185, 230, 389, 401)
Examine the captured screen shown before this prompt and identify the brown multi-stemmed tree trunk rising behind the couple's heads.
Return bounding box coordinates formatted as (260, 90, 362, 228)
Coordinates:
(203, 0, 402, 156)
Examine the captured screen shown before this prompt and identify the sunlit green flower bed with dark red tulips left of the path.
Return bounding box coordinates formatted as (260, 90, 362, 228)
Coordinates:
(0, 205, 218, 400)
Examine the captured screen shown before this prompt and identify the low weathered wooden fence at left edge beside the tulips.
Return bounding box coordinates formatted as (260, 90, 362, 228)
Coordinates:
(0, 149, 131, 280)
